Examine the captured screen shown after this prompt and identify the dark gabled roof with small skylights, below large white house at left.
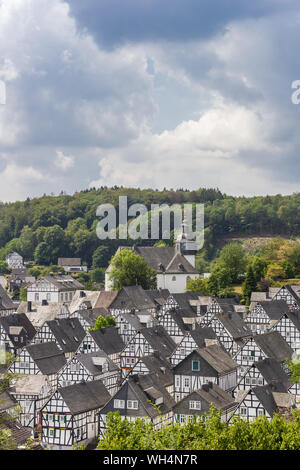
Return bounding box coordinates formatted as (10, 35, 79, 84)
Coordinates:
(47, 318, 86, 353)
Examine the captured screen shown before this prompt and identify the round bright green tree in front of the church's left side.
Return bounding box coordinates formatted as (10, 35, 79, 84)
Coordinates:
(110, 249, 156, 290)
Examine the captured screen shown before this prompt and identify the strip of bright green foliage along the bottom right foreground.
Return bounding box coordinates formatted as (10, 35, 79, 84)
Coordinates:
(97, 407, 300, 451)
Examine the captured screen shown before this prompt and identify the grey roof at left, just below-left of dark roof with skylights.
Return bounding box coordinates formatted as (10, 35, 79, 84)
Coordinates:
(26, 342, 67, 375)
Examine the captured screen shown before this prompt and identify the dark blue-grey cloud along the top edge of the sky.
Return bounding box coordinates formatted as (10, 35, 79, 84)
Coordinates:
(67, 0, 295, 48)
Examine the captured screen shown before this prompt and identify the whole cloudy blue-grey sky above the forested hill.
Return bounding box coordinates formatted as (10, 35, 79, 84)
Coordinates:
(0, 0, 300, 201)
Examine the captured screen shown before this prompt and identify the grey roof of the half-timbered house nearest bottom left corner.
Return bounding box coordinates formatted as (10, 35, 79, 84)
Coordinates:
(58, 380, 111, 414)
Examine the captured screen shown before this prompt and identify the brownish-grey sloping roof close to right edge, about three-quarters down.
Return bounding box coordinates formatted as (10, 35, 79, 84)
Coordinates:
(253, 331, 294, 362)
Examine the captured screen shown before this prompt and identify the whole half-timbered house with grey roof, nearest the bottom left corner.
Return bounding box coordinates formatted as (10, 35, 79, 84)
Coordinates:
(40, 380, 111, 450)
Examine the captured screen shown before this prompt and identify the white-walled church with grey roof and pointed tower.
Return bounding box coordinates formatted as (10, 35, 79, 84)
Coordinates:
(105, 220, 199, 294)
